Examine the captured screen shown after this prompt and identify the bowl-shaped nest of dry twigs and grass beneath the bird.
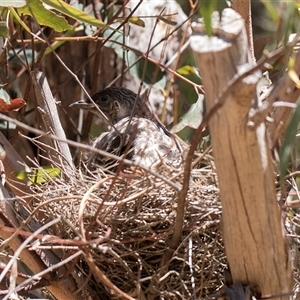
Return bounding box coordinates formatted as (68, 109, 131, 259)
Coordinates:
(25, 157, 226, 299)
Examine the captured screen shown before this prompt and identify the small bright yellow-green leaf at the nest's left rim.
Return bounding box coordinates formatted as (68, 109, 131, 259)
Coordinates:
(14, 166, 61, 184)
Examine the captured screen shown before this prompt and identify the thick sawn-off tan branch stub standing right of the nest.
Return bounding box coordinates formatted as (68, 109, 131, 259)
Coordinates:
(191, 9, 292, 299)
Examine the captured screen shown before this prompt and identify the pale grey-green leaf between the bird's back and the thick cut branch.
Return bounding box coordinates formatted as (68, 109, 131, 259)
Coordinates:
(171, 94, 204, 133)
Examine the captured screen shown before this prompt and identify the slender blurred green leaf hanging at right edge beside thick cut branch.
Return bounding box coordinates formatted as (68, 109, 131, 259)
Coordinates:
(279, 101, 300, 182)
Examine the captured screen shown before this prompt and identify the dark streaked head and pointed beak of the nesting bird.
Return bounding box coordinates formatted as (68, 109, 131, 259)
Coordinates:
(70, 87, 153, 124)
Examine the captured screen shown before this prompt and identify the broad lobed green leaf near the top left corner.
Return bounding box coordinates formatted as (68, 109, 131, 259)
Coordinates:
(18, 0, 73, 32)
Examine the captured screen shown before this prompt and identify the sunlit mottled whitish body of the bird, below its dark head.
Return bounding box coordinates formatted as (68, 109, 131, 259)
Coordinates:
(89, 117, 182, 168)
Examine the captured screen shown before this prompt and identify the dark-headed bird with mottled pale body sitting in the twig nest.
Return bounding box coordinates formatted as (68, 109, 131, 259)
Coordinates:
(70, 87, 183, 169)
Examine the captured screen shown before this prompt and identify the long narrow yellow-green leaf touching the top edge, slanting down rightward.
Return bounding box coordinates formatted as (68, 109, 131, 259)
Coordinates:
(43, 0, 108, 28)
